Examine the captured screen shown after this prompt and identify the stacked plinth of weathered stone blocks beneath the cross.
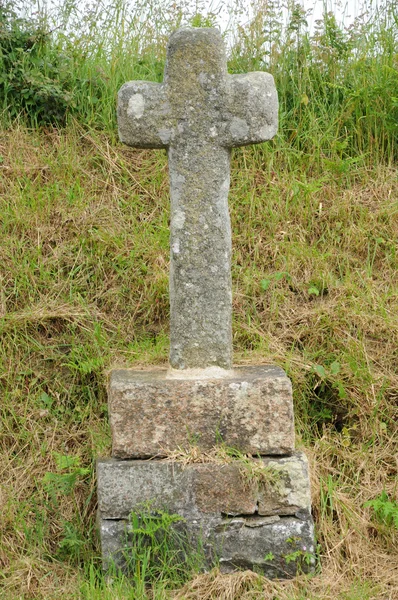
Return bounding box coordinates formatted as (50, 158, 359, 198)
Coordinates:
(97, 366, 314, 577)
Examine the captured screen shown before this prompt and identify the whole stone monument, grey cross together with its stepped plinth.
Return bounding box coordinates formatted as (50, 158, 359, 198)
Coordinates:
(97, 28, 314, 577)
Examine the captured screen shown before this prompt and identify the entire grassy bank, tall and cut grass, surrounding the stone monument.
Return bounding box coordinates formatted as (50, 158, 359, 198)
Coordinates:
(0, 0, 398, 600)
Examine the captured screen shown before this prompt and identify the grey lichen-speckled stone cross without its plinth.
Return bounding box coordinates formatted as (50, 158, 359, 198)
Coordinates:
(118, 28, 278, 369)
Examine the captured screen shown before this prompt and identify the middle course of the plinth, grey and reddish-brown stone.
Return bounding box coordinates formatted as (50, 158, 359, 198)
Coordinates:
(97, 452, 311, 519)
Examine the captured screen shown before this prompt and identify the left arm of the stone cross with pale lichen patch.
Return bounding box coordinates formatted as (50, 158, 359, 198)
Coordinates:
(117, 81, 171, 148)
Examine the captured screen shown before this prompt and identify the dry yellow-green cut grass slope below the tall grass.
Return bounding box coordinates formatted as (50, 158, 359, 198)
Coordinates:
(0, 1, 398, 600)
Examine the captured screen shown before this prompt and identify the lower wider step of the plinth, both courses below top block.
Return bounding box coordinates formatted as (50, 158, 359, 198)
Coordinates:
(97, 453, 314, 577)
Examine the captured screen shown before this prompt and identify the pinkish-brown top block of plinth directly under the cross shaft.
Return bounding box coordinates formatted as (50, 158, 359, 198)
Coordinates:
(108, 366, 294, 458)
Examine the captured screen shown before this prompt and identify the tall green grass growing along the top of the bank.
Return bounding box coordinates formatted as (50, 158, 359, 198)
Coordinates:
(0, 0, 398, 162)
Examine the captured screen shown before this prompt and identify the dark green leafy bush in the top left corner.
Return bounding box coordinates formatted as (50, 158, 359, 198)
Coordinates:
(0, 1, 105, 125)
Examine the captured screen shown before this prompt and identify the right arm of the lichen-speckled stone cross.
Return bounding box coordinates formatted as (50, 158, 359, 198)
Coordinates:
(223, 71, 278, 148)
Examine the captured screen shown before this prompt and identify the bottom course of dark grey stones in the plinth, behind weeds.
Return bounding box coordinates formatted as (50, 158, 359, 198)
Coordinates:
(99, 513, 315, 579)
